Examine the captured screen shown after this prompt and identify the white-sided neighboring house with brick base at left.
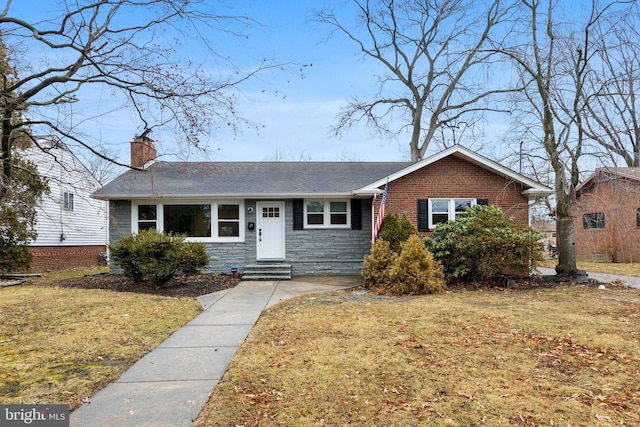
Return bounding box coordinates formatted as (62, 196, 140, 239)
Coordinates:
(25, 137, 108, 271)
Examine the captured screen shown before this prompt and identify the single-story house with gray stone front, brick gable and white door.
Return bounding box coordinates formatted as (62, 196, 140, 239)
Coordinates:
(94, 141, 552, 278)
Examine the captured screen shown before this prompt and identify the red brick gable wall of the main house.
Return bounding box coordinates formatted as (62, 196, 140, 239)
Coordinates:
(376, 156, 529, 236)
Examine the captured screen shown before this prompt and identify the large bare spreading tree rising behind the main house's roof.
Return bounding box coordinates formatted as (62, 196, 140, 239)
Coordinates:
(315, 0, 512, 161)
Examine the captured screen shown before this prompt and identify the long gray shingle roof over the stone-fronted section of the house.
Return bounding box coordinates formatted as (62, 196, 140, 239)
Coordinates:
(94, 162, 411, 200)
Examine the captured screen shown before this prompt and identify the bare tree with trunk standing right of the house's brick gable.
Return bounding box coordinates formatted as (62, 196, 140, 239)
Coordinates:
(502, 0, 608, 275)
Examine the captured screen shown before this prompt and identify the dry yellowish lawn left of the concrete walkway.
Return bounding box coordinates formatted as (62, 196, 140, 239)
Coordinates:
(0, 282, 200, 409)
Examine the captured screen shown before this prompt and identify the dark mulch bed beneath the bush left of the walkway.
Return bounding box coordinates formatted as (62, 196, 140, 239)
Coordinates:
(38, 274, 242, 298)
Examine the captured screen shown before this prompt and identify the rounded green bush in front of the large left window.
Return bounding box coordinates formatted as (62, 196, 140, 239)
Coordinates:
(109, 229, 209, 285)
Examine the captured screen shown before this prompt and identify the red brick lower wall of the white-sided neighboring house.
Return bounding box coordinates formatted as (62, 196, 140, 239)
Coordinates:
(29, 245, 106, 272)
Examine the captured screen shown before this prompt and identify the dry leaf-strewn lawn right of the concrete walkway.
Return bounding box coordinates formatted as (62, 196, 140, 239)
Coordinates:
(195, 286, 640, 426)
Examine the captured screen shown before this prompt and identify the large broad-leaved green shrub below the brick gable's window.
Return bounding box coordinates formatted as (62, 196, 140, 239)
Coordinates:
(424, 205, 543, 281)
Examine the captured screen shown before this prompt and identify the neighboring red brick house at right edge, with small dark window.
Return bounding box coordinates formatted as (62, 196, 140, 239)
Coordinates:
(571, 168, 640, 262)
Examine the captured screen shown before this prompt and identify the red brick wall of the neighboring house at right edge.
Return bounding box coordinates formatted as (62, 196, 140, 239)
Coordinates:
(571, 179, 640, 262)
